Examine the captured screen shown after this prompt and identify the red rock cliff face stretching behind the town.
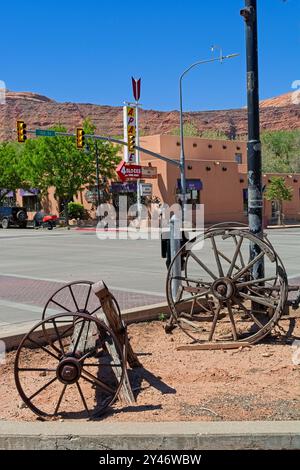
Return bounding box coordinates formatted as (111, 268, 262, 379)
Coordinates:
(0, 88, 300, 140)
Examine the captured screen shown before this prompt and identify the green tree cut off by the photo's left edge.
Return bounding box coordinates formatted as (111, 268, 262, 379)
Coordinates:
(0, 142, 28, 204)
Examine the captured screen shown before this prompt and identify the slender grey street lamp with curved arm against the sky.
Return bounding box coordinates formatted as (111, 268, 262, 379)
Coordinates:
(179, 50, 239, 212)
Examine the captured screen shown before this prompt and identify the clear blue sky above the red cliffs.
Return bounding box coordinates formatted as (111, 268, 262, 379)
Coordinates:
(0, 0, 300, 111)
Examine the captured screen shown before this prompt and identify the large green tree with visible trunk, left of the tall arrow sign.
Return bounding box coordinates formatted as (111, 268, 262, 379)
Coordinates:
(22, 121, 119, 224)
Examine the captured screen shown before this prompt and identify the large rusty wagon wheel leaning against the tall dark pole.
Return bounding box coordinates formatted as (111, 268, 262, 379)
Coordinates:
(166, 227, 288, 343)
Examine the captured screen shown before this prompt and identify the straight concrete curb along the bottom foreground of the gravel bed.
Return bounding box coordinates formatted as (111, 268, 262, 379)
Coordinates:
(0, 421, 300, 451)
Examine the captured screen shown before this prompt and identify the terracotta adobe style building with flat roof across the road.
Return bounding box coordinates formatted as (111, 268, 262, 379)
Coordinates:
(11, 135, 300, 224)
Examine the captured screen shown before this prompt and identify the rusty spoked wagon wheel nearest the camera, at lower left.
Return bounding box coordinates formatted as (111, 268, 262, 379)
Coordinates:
(14, 312, 126, 418)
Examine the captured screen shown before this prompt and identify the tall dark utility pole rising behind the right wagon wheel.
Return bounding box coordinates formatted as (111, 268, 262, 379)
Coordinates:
(241, 0, 264, 279)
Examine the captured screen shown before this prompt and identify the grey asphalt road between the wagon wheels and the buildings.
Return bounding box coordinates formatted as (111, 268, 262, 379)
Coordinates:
(0, 228, 300, 328)
